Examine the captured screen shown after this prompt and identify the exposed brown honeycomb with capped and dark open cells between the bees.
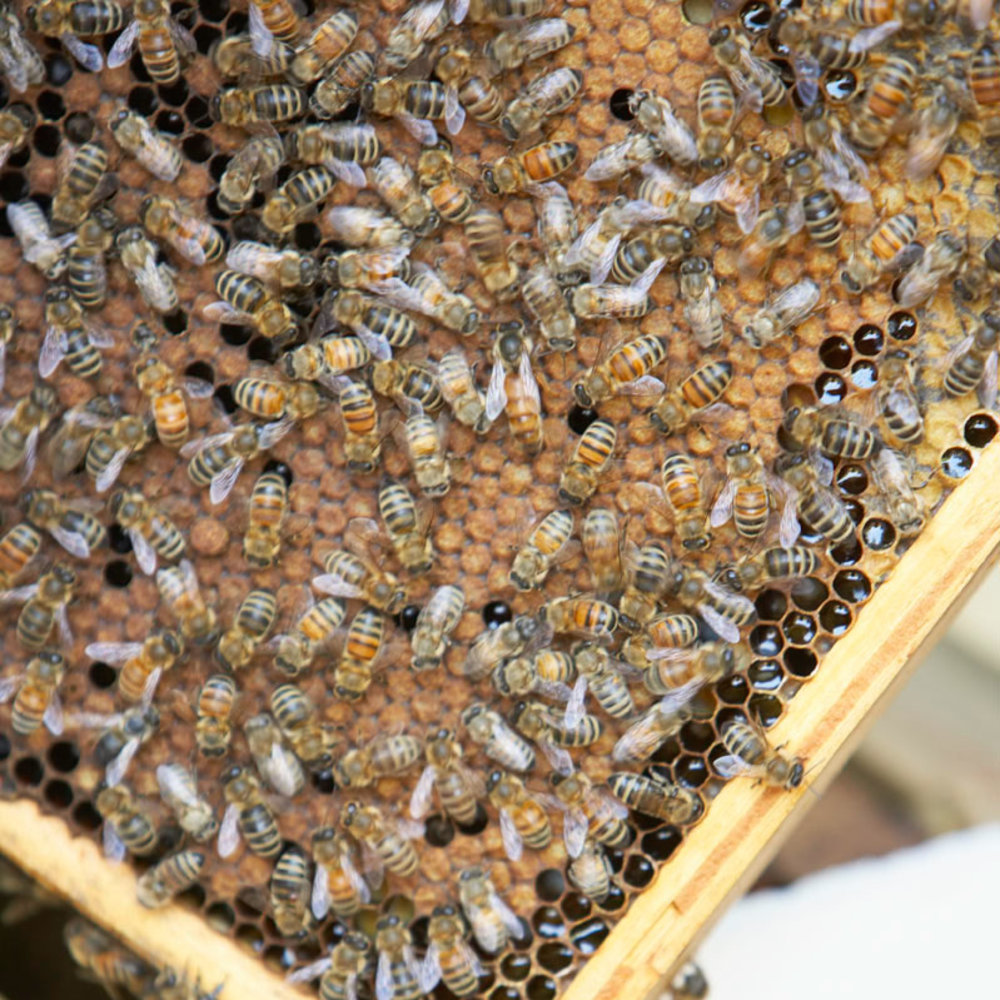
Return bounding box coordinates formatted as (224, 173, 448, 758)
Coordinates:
(0, 0, 997, 1000)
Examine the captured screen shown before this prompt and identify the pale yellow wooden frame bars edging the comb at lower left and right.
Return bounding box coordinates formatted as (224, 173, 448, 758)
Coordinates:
(0, 444, 1000, 1000)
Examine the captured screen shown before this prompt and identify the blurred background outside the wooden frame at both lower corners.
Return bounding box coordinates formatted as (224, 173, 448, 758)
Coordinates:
(0, 569, 1000, 1000)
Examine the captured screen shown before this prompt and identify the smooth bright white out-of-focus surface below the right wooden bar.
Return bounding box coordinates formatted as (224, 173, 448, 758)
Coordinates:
(696, 824, 1000, 1000)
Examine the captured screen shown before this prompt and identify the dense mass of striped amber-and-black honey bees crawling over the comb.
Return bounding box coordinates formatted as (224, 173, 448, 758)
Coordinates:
(0, 0, 1000, 1000)
